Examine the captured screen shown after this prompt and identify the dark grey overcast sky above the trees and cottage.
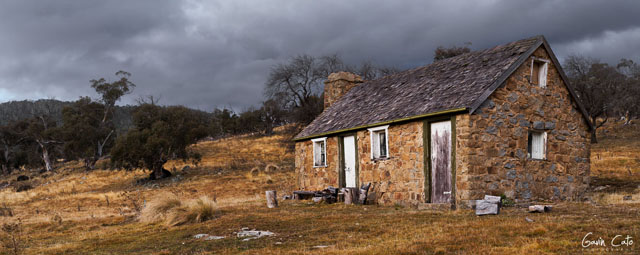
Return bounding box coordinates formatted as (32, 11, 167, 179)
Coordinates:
(0, 0, 640, 110)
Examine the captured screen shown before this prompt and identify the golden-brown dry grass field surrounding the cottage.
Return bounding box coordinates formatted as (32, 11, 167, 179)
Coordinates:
(0, 123, 640, 254)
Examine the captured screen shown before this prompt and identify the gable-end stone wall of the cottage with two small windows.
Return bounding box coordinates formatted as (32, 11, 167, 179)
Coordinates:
(456, 45, 590, 205)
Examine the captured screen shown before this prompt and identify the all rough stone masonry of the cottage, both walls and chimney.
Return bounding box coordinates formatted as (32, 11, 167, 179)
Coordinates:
(295, 39, 590, 207)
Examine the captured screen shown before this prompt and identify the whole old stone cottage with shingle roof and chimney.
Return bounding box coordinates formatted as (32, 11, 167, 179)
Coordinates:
(294, 36, 592, 208)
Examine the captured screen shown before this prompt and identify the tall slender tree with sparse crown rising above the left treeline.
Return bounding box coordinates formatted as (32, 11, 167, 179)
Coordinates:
(90, 71, 136, 159)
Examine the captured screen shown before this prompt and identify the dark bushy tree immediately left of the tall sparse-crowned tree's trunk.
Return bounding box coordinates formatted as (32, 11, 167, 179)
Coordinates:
(61, 97, 114, 170)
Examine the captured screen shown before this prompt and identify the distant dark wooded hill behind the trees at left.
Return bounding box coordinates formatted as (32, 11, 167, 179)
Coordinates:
(0, 99, 135, 133)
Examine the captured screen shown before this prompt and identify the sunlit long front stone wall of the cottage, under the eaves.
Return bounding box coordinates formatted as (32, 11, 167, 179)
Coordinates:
(295, 121, 424, 205)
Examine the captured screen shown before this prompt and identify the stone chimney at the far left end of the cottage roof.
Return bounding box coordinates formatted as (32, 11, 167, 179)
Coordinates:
(324, 72, 362, 109)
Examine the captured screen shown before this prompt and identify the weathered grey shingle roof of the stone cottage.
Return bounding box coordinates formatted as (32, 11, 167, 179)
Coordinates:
(295, 36, 592, 140)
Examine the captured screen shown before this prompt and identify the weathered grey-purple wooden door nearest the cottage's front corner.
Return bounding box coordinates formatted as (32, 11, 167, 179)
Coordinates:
(429, 121, 451, 203)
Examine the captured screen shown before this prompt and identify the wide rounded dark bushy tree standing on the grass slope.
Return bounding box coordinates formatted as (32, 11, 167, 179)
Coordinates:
(111, 104, 207, 180)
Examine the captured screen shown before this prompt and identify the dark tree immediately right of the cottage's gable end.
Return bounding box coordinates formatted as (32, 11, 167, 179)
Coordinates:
(564, 56, 626, 143)
